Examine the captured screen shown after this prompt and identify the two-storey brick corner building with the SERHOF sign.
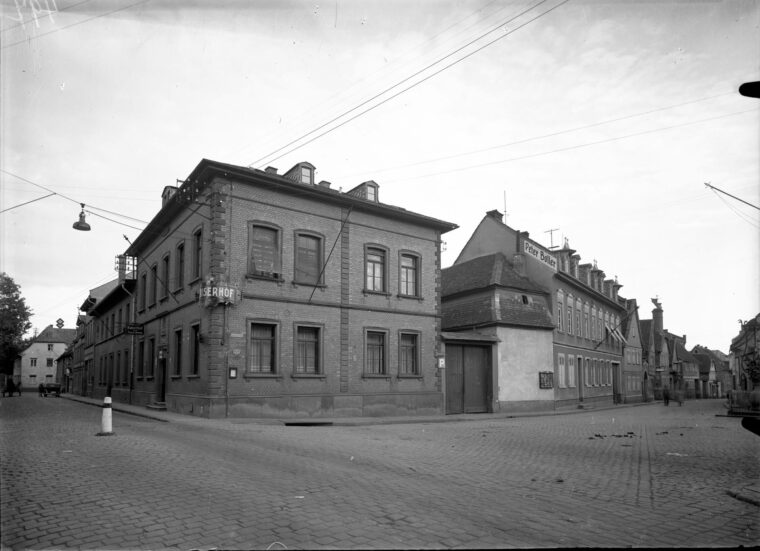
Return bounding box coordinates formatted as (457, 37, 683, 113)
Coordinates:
(79, 159, 456, 418)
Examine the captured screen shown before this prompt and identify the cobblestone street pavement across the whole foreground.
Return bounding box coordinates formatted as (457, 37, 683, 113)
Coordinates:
(0, 395, 760, 549)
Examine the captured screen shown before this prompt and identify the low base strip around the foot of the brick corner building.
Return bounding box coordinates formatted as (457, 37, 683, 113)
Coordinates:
(166, 393, 443, 419)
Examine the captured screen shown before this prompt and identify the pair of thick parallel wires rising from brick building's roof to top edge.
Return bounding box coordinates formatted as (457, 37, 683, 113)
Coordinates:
(248, 0, 570, 167)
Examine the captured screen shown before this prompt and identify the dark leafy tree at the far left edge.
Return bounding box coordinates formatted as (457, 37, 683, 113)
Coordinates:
(0, 272, 32, 375)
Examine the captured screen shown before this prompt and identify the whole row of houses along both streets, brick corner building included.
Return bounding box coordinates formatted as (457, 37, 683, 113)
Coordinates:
(7, 159, 744, 417)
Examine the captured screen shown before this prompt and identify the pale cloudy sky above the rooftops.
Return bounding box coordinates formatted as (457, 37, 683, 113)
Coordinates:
(0, 0, 760, 352)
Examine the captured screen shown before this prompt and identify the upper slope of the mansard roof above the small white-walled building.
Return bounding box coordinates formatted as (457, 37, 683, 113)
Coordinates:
(441, 253, 547, 297)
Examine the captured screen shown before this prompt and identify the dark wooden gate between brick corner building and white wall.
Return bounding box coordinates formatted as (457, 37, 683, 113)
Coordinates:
(446, 344, 491, 413)
